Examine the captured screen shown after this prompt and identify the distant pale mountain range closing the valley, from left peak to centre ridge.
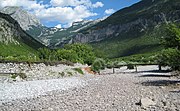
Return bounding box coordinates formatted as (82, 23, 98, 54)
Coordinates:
(1, 6, 103, 48)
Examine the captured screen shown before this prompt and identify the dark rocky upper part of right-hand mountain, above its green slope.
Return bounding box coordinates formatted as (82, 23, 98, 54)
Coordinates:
(72, 0, 180, 43)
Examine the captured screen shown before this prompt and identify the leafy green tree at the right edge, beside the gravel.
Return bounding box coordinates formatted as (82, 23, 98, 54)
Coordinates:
(158, 24, 180, 70)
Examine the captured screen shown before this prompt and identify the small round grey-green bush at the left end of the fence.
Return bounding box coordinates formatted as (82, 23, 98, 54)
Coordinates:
(91, 58, 105, 72)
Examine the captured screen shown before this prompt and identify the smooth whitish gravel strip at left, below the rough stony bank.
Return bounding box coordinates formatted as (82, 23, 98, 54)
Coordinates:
(0, 77, 86, 101)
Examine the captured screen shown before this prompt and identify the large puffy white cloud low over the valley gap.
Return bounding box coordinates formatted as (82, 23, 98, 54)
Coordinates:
(35, 5, 97, 23)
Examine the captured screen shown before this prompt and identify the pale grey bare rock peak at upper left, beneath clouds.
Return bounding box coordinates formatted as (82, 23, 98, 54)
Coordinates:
(1, 6, 40, 30)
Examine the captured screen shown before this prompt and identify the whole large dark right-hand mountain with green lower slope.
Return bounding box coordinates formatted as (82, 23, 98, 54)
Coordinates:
(71, 0, 180, 58)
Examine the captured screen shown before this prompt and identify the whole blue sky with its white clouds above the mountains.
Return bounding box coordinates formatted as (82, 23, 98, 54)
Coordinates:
(0, 0, 140, 28)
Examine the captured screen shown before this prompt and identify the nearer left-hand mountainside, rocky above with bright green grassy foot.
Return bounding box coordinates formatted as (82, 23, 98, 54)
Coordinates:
(0, 13, 44, 57)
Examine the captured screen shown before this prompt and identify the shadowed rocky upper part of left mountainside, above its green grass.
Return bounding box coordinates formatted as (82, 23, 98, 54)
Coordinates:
(0, 13, 44, 49)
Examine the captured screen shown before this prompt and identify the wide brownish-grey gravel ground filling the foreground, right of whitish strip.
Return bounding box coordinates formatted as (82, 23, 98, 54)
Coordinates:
(0, 66, 180, 111)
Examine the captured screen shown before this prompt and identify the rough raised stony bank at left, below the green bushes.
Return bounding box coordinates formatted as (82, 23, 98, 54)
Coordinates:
(0, 63, 87, 83)
